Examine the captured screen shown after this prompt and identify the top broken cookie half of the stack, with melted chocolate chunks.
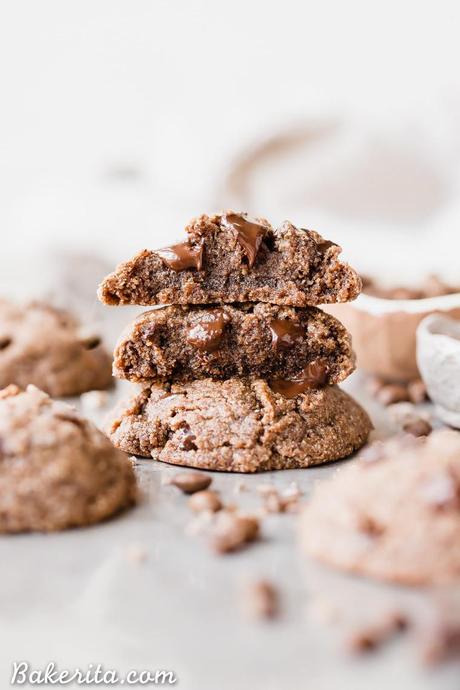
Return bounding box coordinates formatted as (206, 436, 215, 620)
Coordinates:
(99, 211, 361, 307)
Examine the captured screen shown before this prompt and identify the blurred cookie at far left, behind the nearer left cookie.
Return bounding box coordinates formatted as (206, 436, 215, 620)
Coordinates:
(0, 300, 112, 396)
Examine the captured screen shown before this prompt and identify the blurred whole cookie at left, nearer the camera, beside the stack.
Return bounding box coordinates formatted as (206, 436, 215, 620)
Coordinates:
(0, 385, 137, 533)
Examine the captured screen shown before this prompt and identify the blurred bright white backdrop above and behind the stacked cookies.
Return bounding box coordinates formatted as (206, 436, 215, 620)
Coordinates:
(0, 0, 460, 294)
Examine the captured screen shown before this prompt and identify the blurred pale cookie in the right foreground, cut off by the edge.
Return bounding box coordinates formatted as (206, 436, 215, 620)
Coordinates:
(301, 429, 460, 585)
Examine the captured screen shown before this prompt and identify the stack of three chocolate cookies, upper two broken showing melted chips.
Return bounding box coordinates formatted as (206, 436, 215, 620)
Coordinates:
(99, 211, 371, 472)
